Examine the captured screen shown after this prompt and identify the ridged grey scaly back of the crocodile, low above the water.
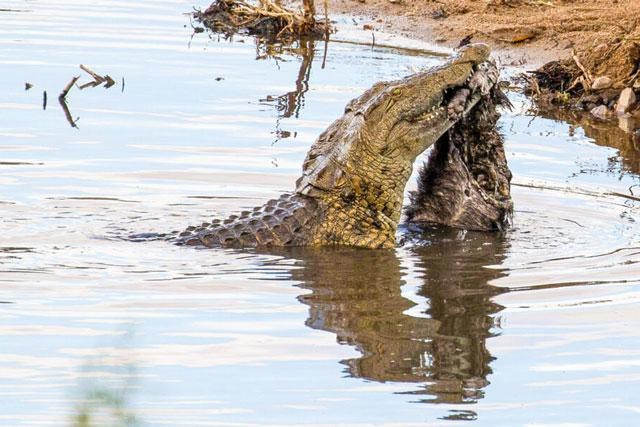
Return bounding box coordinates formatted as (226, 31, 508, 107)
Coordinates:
(176, 194, 318, 248)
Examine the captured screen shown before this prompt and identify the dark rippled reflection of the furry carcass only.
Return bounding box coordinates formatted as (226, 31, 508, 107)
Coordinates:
(416, 230, 507, 402)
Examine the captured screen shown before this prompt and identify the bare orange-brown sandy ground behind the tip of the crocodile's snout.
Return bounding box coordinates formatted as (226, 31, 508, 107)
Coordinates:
(331, 0, 640, 65)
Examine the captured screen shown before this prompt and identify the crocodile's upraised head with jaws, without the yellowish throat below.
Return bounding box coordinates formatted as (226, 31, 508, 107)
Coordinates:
(296, 44, 498, 201)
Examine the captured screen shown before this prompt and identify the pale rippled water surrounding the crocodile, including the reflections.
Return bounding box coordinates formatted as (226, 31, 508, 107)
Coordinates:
(0, 0, 640, 426)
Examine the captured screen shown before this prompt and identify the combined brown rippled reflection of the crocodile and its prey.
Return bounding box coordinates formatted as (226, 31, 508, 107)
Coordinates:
(278, 230, 506, 403)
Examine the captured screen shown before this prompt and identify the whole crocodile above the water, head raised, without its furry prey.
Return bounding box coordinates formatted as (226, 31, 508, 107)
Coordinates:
(169, 44, 510, 248)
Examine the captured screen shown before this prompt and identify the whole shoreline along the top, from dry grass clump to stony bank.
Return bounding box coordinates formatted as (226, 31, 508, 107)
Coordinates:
(195, 0, 640, 130)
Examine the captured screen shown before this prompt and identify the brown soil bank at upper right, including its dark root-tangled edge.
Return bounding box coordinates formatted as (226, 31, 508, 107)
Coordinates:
(330, 0, 640, 123)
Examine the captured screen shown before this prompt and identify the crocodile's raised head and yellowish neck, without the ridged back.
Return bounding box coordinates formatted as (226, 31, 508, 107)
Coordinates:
(296, 44, 498, 247)
